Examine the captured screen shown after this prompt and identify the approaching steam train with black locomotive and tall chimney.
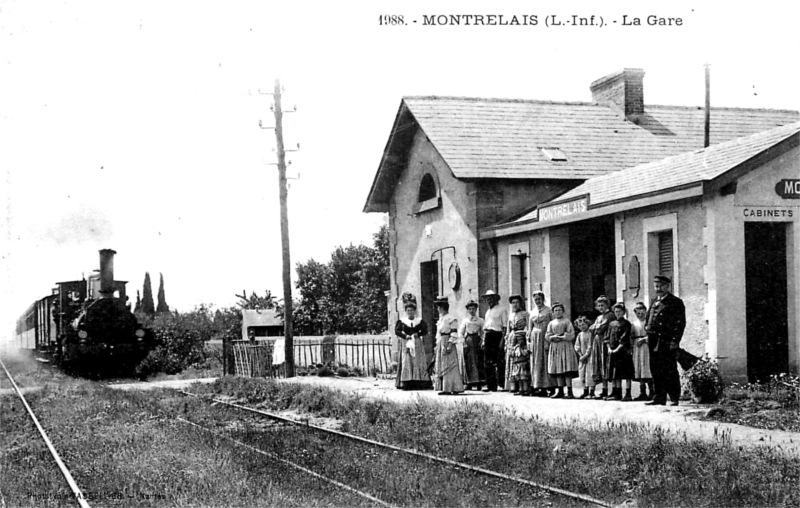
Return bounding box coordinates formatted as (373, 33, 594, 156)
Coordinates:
(16, 249, 155, 377)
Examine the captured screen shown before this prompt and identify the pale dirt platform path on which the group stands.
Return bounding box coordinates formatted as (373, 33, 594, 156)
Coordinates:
(283, 376, 800, 457)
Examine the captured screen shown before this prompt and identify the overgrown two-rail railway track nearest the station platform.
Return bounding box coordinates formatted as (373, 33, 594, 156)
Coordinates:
(176, 390, 614, 507)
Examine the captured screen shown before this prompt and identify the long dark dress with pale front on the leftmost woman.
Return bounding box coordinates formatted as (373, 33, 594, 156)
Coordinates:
(394, 318, 433, 390)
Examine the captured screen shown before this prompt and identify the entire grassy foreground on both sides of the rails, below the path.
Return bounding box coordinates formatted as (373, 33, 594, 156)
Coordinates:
(0, 356, 800, 507)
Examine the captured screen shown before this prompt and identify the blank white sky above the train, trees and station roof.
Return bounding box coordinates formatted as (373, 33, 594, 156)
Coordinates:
(0, 0, 800, 338)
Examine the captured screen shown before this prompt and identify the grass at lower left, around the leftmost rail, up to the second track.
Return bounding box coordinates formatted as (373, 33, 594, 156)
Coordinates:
(0, 382, 382, 507)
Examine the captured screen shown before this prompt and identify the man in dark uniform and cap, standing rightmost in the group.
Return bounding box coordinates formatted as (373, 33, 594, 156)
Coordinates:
(645, 275, 686, 406)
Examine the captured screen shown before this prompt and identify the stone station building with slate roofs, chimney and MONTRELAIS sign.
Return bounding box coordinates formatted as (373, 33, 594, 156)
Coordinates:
(364, 69, 800, 380)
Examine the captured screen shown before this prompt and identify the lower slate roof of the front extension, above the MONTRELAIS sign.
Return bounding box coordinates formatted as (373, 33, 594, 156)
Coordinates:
(509, 122, 800, 224)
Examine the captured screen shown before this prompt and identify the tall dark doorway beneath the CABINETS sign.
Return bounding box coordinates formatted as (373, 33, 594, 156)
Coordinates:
(744, 222, 789, 382)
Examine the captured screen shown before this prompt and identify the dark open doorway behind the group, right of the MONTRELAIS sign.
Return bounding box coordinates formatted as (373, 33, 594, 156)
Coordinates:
(569, 216, 617, 320)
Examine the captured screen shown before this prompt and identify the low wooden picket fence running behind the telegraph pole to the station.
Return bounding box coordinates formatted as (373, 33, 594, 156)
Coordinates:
(231, 335, 392, 377)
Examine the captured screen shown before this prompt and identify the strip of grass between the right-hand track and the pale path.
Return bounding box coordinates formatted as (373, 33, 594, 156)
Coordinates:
(198, 378, 800, 506)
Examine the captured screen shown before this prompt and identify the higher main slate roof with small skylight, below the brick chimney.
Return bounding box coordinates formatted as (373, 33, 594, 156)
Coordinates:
(364, 97, 800, 212)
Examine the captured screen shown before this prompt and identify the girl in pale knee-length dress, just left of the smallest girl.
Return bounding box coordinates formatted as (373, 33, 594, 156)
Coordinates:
(544, 302, 578, 399)
